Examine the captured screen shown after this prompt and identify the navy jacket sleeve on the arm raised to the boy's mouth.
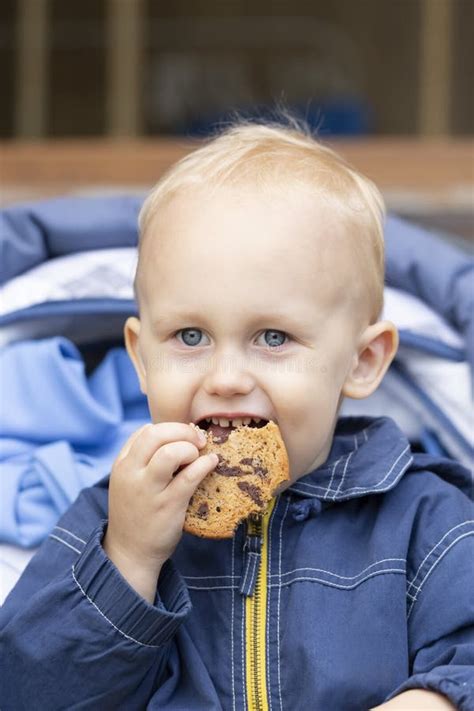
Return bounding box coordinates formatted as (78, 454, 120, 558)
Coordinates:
(0, 478, 191, 711)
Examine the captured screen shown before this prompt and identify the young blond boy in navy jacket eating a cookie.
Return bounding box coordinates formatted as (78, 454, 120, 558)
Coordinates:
(0, 119, 474, 711)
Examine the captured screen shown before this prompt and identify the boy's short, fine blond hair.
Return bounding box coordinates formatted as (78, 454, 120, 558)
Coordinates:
(135, 114, 385, 323)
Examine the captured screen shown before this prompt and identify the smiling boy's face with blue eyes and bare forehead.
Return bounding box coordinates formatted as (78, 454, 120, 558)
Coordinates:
(126, 189, 378, 481)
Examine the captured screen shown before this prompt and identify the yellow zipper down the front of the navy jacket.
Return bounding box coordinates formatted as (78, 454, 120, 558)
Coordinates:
(245, 499, 275, 711)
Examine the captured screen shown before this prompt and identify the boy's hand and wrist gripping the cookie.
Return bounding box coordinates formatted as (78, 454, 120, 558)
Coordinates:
(102, 422, 218, 603)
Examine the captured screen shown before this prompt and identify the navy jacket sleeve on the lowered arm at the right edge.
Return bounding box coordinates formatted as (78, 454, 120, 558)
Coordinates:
(390, 516, 474, 711)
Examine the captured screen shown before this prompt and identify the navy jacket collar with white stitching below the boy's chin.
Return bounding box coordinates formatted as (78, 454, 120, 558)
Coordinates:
(286, 417, 413, 520)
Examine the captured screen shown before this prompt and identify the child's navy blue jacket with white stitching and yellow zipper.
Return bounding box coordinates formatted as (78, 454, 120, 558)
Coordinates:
(0, 417, 474, 711)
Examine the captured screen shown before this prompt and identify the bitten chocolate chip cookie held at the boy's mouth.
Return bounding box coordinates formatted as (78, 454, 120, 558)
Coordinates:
(184, 421, 290, 538)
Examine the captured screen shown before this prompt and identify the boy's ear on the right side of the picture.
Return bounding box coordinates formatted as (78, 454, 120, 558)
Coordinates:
(342, 321, 398, 400)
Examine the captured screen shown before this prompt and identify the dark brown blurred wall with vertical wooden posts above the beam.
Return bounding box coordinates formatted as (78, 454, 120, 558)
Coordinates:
(0, 0, 474, 138)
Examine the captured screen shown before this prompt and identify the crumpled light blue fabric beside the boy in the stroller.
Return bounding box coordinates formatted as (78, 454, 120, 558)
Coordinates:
(0, 337, 149, 547)
